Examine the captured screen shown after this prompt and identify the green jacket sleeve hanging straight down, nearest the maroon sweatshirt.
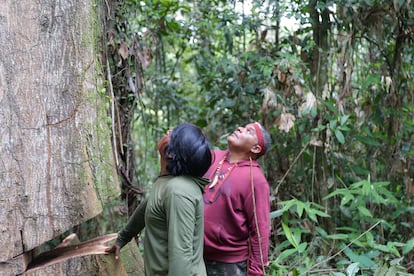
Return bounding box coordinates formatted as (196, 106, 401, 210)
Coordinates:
(165, 187, 197, 275)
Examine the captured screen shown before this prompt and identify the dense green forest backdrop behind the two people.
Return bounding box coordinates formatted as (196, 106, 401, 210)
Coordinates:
(104, 0, 414, 275)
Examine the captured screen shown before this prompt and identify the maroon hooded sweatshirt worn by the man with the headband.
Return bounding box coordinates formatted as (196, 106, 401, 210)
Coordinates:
(203, 150, 270, 275)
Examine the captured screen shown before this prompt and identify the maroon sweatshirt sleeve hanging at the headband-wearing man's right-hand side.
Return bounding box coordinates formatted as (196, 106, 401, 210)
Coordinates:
(246, 173, 270, 276)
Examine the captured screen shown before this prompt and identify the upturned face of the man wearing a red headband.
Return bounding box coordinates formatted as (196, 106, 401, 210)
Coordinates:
(227, 124, 258, 152)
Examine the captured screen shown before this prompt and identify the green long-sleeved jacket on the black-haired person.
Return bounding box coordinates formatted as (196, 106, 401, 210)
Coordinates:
(117, 176, 208, 276)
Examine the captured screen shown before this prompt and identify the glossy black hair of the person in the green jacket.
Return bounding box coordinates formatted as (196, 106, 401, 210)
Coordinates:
(166, 123, 211, 177)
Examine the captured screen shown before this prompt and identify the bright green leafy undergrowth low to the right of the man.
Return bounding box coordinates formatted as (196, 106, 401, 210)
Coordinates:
(269, 178, 414, 275)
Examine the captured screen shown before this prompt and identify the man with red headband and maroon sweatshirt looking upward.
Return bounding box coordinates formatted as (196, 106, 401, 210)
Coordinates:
(203, 122, 270, 276)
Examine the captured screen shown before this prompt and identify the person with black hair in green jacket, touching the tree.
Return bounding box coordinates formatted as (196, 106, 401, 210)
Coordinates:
(106, 123, 212, 276)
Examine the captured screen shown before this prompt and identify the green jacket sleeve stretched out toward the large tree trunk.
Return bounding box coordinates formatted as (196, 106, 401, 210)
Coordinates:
(116, 198, 148, 248)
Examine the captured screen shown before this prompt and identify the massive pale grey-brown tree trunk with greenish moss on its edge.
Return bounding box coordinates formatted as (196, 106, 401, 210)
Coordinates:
(0, 0, 139, 275)
